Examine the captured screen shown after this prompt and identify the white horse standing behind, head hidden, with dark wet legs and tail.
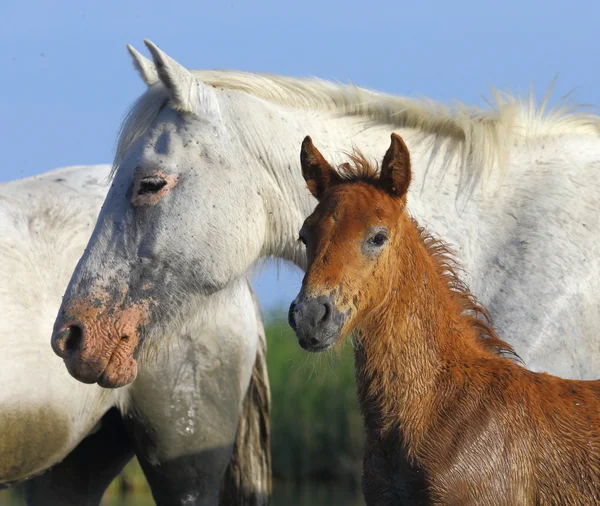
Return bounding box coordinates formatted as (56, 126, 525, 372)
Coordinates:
(0, 165, 270, 506)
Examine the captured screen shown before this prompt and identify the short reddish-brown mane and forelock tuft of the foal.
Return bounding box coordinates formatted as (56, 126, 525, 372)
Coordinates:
(337, 149, 522, 363)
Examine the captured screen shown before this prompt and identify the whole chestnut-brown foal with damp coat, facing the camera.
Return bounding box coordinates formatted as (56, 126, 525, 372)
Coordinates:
(290, 136, 600, 506)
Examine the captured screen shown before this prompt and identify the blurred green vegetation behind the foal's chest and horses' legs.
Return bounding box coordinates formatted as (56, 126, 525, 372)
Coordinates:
(0, 314, 363, 506)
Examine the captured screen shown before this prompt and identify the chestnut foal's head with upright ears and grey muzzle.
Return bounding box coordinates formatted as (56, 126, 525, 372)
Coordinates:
(289, 134, 411, 351)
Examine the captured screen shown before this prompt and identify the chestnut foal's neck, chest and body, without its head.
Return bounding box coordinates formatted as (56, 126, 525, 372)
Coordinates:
(355, 224, 600, 506)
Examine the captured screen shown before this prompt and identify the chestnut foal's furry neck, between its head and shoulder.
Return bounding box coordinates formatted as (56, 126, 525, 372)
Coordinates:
(355, 215, 496, 454)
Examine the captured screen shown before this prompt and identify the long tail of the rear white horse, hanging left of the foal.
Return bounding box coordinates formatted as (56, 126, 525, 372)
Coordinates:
(220, 282, 271, 506)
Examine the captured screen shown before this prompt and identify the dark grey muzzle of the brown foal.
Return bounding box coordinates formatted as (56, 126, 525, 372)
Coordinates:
(288, 295, 345, 352)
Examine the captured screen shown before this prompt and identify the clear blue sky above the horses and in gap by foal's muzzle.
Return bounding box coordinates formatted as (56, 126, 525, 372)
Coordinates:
(0, 0, 600, 308)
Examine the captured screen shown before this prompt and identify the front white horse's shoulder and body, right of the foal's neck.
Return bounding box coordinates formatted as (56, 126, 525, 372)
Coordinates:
(409, 132, 600, 379)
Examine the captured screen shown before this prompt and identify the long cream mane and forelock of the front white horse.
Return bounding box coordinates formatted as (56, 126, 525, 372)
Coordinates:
(113, 70, 600, 183)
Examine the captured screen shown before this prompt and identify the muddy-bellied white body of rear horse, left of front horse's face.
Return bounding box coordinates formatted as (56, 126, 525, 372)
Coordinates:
(0, 166, 119, 483)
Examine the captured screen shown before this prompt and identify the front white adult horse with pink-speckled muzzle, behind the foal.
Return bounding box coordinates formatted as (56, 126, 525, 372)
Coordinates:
(53, 41, 600, 404)
